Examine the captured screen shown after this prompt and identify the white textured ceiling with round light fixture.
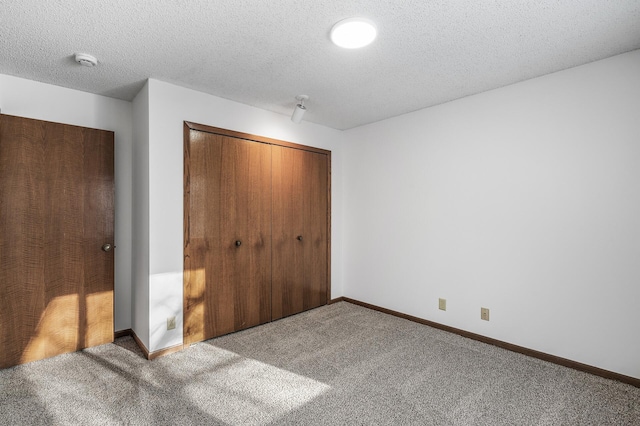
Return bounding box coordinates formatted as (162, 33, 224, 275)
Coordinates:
(0, 0, 640, 129)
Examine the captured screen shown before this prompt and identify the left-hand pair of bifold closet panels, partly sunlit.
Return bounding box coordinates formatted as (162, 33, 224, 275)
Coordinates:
(184, 130, 271, 344)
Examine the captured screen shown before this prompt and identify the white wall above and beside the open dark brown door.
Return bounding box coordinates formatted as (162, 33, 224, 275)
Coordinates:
(0, 75, 132, 330)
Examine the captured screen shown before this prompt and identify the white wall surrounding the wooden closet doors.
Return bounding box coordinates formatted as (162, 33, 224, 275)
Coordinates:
(148, 79, 343, 351)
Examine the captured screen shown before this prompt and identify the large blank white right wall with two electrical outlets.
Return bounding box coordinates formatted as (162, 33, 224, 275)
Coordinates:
(343, 51, 640, 378)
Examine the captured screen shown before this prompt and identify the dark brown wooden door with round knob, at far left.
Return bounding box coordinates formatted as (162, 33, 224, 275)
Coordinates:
(0, 115, 114, 368)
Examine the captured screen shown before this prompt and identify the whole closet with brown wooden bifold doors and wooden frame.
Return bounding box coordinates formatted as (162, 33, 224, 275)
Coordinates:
(184, 122, 331, 344)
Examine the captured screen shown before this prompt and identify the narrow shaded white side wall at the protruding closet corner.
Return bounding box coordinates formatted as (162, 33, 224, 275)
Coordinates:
(131, 84, 149, 348)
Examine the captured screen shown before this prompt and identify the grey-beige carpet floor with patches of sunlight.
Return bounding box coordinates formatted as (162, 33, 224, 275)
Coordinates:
(0, 302, 640, 426)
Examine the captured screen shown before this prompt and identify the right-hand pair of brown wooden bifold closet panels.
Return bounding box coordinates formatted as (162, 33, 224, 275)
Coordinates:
(272, 146, 329, 320)
